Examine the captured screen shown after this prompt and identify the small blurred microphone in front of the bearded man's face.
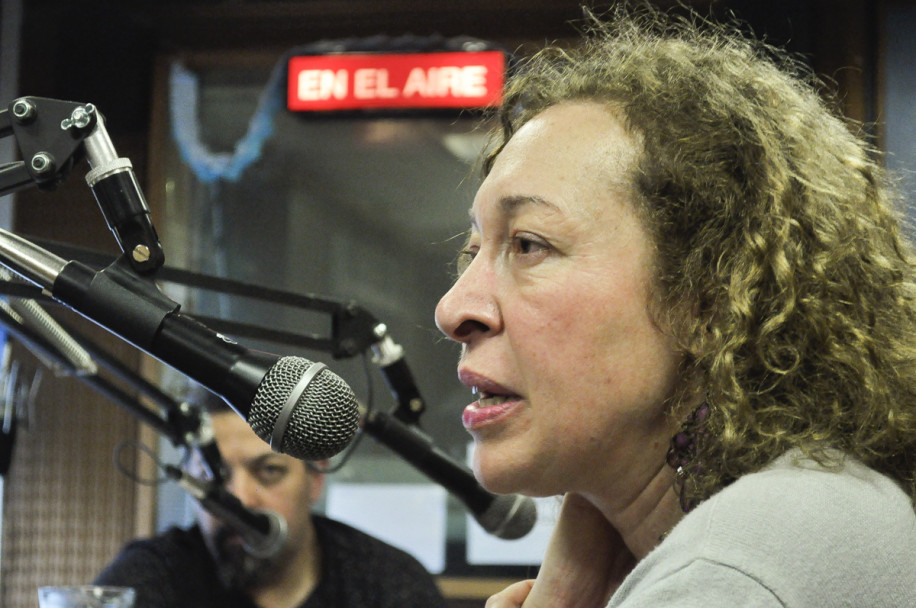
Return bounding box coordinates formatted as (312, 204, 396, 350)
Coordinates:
(166, 465, 287, 558)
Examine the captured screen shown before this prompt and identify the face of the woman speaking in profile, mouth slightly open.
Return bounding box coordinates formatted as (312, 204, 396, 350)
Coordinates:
(436, 102, 681, 506)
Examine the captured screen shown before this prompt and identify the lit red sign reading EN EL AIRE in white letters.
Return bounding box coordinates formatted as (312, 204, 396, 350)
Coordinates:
(287, 51, 506, 111)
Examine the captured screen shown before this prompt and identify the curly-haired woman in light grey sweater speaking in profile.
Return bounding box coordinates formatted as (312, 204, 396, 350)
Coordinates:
(436, 5, 916, 608)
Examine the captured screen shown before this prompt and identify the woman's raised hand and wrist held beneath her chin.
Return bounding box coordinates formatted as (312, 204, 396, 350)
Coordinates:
(486, 494, 636, 608)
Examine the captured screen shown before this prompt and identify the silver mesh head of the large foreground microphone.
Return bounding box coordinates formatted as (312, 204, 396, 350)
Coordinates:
(248, 357, 359, 460)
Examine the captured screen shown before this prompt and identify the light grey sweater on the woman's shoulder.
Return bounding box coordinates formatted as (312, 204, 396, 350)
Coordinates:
(608, 453, 916, 608)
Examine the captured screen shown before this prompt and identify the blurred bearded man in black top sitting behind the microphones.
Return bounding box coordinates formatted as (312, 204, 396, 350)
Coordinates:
(96, 388, 446, 608)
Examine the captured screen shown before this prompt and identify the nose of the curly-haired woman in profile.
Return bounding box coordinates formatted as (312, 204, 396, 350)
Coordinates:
(436, 258, 501, 344)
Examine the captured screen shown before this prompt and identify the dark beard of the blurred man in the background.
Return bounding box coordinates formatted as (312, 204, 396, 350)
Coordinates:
(206, 526, 283, 590)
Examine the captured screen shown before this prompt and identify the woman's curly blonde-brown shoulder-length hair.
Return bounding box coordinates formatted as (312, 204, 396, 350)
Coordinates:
(484, 8, 916, 505)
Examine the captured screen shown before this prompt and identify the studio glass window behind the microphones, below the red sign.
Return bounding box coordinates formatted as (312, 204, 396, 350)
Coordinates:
(151, 52, 541, 577)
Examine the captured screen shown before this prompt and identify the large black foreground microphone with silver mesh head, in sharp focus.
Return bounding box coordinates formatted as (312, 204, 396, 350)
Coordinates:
(0, 230, 359, 460)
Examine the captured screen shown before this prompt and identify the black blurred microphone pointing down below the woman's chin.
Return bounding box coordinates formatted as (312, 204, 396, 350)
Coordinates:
(363, 411, 537, 540)
